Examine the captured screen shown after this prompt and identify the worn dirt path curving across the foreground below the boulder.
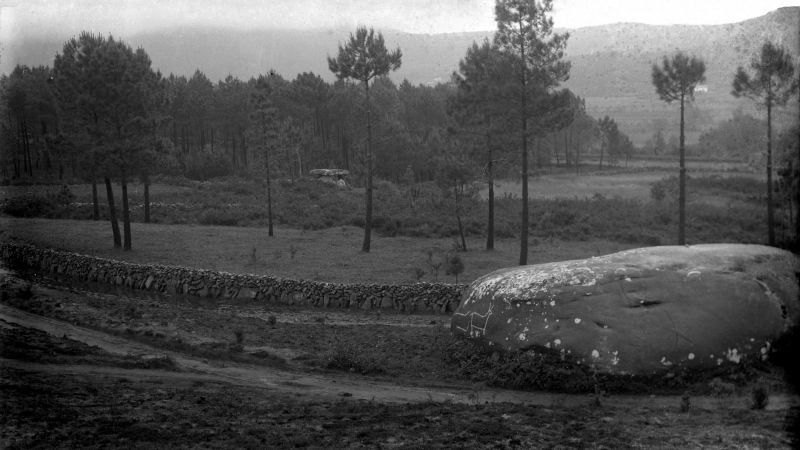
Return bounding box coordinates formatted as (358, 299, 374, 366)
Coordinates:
(0, 304, 793, 410)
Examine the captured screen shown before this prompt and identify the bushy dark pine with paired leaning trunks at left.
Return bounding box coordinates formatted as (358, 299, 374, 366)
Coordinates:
(53, 32, 161, 250)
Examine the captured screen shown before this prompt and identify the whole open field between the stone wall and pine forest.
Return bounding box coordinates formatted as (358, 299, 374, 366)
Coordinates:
(0, 159, 786, 283)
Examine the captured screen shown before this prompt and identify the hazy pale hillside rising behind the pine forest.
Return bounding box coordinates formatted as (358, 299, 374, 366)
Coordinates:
(0, 7, 800, 144)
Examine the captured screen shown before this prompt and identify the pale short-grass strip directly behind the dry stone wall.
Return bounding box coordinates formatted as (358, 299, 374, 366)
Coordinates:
(0, 217, 636, 283)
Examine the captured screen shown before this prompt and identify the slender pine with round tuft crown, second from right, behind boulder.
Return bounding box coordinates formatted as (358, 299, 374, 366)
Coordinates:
(652, 52, 706, 245)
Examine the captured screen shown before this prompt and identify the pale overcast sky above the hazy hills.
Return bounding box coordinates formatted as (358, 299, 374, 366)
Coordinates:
(0, 0, 799, 39)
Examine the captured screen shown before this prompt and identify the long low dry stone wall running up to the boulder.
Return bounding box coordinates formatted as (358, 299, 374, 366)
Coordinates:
(0, 242, 465, 314)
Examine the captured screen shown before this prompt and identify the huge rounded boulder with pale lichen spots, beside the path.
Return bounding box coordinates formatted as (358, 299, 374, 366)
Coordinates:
(451, 244, 800, 375)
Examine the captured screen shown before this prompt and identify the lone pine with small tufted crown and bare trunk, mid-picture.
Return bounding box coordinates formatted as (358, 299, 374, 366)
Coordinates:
(328, 27, 403, 252)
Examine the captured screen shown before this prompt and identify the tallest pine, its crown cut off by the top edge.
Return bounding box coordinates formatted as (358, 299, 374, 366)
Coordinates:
(495, 0, 570, 265)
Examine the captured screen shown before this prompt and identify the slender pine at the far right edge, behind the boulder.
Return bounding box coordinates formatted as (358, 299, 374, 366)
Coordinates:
(731, 41, 798, 245)
